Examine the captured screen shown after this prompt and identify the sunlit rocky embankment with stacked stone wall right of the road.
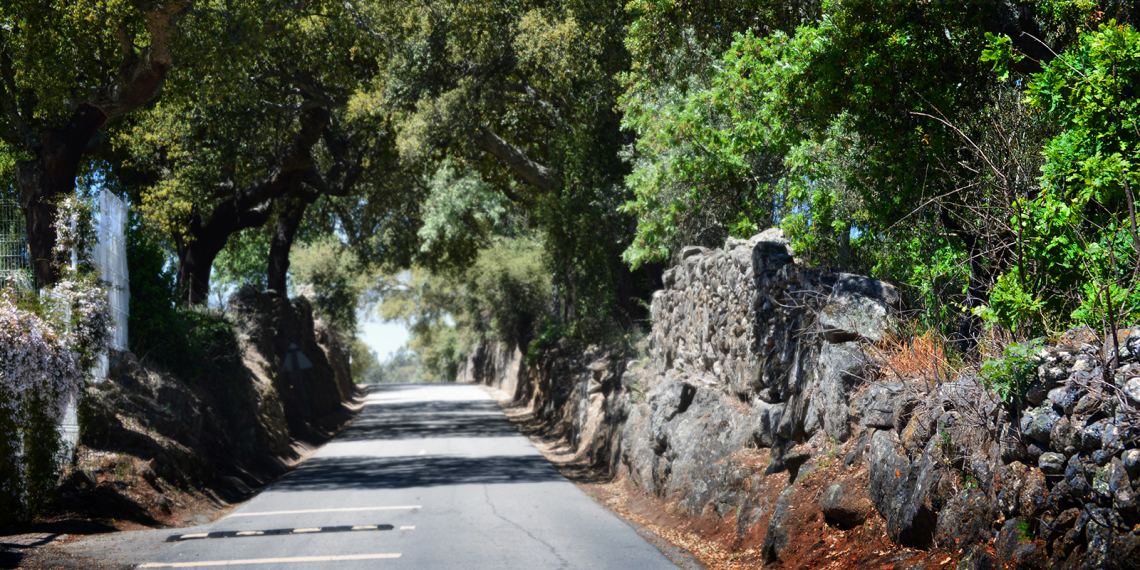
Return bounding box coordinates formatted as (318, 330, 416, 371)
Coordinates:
(459, 230, 1140, 569)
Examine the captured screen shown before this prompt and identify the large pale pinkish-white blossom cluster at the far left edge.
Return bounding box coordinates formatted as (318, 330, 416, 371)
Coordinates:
(0, 295, 83, 424)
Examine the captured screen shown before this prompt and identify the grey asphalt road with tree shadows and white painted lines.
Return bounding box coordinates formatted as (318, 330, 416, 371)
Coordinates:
(80, 384, 677, 570)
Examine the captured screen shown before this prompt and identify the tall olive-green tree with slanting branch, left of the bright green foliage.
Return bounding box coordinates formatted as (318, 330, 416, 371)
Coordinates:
(353, 0, 661, 328)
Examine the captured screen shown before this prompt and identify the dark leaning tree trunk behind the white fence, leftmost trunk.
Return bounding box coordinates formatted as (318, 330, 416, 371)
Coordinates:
(16, 105, 107, 287)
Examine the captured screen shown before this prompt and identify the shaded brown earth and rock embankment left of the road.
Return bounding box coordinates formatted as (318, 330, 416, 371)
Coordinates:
(60, 288, 357, 526)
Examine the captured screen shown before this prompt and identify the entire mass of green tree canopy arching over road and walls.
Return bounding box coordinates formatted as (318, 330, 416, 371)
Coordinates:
(0, 0, 1140, 375)
